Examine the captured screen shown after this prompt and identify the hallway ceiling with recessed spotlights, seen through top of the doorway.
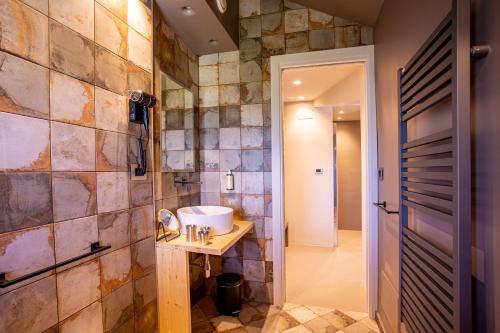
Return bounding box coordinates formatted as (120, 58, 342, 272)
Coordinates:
(282, 64, 363, 102)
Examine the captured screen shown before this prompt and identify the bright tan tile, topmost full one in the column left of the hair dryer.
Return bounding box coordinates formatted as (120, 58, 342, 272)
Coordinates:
(95, 3, 128, 58)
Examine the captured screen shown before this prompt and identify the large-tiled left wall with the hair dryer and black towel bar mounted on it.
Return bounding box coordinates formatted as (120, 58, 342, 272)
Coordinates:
(0, 0, 157, 332)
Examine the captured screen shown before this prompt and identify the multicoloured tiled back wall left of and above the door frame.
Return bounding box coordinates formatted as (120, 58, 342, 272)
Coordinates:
(199, 0, 372, 302)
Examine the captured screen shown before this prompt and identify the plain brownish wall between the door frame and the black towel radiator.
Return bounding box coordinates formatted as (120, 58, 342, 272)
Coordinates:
(374, 0, 451, 332)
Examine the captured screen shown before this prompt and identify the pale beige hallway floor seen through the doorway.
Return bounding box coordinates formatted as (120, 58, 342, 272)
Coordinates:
(285, 230, 367, 312)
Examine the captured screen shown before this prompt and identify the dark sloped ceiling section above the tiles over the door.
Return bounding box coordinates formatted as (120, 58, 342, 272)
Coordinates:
(293, 0, 384, 27)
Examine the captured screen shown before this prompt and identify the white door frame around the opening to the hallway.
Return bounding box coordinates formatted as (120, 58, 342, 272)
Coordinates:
(271, 45, 378, 318)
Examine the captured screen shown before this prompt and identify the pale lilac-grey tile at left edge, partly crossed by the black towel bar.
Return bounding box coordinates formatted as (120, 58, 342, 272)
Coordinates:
(0, 225, 54, 294)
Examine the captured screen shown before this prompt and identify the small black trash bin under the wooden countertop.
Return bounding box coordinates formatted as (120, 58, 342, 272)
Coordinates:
(217, 273, 243, 316)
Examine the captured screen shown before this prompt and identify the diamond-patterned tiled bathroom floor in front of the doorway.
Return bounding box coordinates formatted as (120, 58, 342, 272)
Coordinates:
(191, 296, 379, 333)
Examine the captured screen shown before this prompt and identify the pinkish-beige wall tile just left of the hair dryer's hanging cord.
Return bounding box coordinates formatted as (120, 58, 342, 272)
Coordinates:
(96, 130, 128, 171)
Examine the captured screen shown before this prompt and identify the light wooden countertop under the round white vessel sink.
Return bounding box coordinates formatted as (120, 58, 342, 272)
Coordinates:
(156, 220, 253, 256)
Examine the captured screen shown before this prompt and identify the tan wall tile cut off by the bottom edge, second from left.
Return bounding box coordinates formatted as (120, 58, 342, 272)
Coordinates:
(59, 302, 103, 333)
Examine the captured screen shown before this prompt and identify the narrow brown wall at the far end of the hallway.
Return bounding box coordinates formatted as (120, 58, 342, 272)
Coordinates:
(335, 121, 361, 230)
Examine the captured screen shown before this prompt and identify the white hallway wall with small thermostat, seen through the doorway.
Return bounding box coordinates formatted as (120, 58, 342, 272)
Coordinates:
(283, 103, 334, 247)
